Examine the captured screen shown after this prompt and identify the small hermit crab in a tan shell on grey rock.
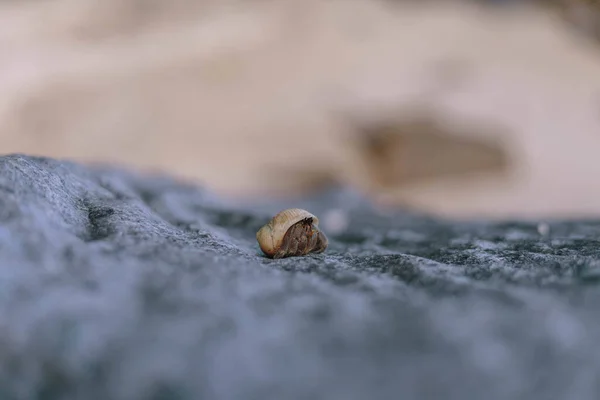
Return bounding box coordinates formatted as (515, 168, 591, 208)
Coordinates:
(256, 208, 328, 258)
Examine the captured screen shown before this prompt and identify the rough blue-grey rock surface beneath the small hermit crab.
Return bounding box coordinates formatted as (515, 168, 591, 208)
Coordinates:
(0, 156, 600, 400)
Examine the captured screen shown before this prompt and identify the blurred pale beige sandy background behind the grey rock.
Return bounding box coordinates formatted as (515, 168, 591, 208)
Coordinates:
(0, 0, 600, 218)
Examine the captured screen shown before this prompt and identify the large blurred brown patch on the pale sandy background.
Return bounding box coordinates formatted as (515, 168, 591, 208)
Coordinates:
(355, 112, 510, 191)
